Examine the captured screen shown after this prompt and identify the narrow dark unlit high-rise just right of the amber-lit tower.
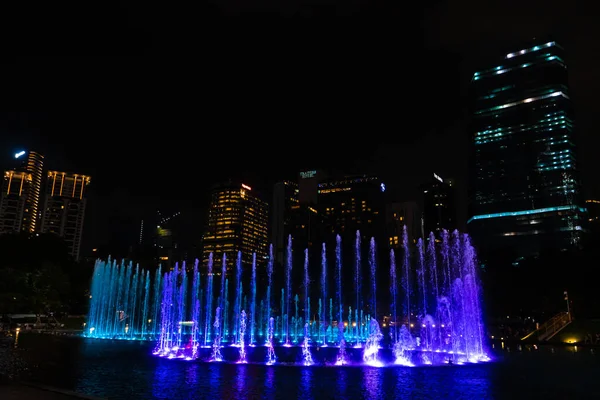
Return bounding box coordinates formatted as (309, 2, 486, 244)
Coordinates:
(271, 181, 299, 265)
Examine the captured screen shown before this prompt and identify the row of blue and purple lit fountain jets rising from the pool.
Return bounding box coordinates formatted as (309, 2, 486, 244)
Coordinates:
(91, 230, 489, 366)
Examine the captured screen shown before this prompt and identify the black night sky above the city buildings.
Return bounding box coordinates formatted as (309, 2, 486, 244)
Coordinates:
(0, 0, 600, 255)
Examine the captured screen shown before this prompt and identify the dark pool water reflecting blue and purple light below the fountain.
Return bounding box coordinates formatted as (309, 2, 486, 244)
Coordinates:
(0, 334, 600, 400)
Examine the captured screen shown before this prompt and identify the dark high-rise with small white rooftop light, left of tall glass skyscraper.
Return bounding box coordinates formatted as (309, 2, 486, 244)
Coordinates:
(421, 173, 457, 236)
